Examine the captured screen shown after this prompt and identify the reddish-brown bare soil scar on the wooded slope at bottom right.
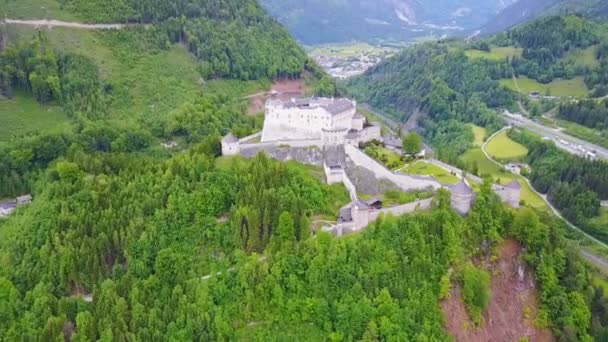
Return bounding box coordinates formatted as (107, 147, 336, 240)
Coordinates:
(441, 240, 555, 342)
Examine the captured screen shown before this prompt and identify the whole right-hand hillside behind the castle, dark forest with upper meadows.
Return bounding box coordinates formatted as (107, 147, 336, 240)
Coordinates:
(346, 16, 608, 161)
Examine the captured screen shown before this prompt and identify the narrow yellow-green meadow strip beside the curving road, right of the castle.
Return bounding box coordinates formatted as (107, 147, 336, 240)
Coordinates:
(461, 148, 548, 210)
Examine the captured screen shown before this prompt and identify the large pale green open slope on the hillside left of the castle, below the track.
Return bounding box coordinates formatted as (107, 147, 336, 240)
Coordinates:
(8, 26, 269, 127)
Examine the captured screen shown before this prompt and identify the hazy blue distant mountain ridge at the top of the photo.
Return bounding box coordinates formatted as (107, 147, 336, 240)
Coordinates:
(261, 0, 518, 45)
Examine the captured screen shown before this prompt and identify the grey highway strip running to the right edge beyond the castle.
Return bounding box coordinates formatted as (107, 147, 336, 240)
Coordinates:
(504, 111, 608, 160)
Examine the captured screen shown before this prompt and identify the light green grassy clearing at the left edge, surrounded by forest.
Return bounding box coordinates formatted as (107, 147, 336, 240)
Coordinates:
(0, 93, 68, 141)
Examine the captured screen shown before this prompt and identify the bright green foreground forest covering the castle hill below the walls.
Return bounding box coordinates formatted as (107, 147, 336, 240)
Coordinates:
(0, 159, 606, 341)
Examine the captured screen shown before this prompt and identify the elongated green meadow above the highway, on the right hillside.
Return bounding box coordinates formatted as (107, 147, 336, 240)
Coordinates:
(500, 76, 589, 97)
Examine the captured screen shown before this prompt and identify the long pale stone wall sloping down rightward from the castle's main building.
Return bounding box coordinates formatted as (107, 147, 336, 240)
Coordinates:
(344, 145, 441, 191)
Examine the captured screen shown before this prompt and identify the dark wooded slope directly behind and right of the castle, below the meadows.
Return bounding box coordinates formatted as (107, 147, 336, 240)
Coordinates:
(347, 43, 515, 162)
